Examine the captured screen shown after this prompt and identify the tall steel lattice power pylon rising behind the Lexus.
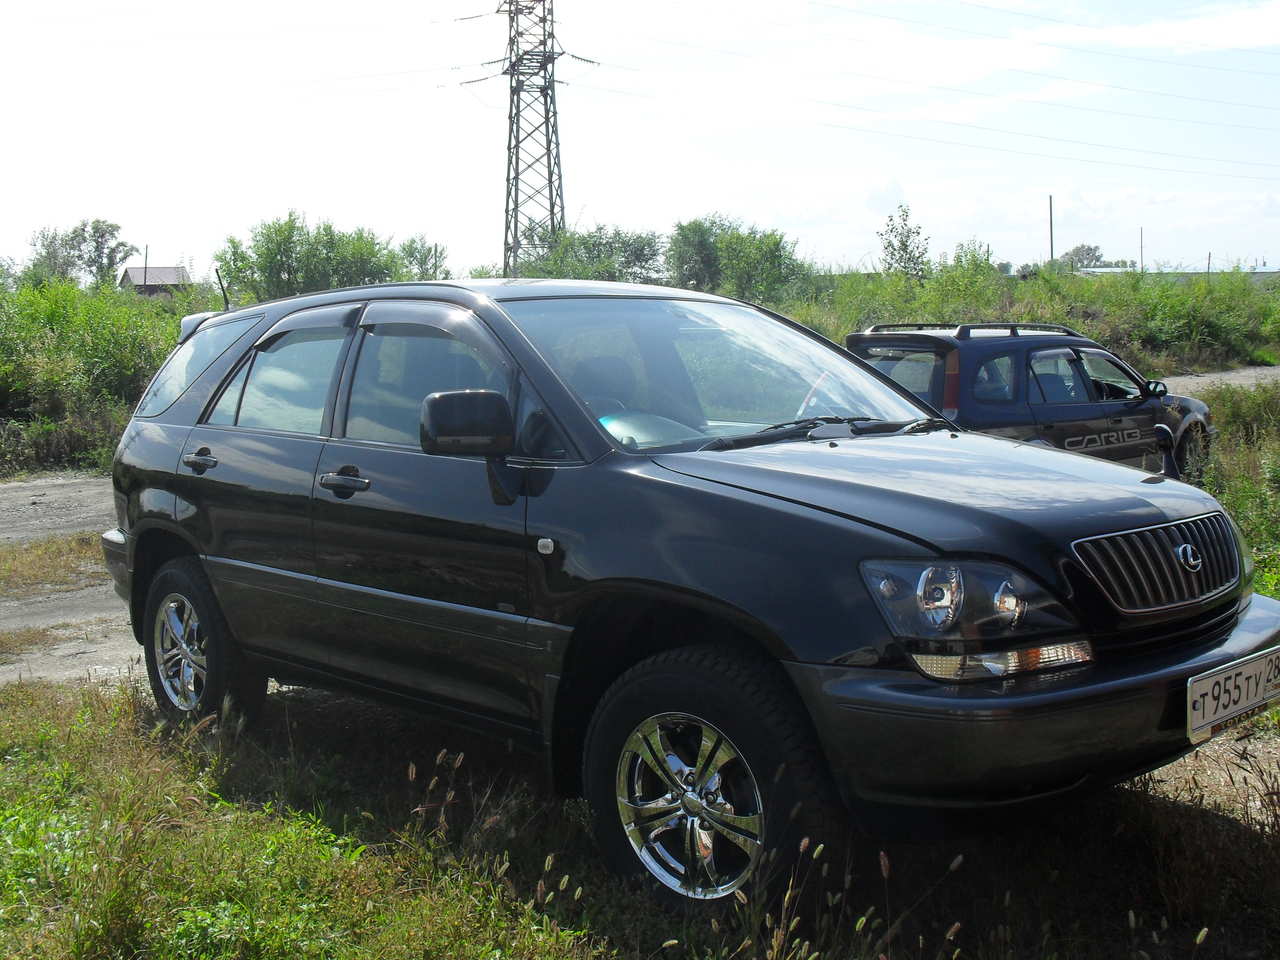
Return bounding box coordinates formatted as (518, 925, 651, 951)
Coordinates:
(498, 0, 564, 276)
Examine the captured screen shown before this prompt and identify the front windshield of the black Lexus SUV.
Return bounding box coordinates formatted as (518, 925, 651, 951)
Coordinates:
(503, 297, 928, 451)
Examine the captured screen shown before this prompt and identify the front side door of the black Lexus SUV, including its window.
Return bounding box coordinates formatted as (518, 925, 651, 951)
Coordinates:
(312, 301, 534, 726)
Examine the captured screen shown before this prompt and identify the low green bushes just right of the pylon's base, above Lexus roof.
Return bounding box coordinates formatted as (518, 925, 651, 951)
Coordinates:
(520, 227, 663, 283)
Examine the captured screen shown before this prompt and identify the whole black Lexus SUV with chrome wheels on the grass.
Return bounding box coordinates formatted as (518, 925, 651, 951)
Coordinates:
(102, 280, 1280, 900)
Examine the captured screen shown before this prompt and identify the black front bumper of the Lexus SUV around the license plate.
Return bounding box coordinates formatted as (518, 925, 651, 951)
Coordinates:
(786, 596, 1280, 808)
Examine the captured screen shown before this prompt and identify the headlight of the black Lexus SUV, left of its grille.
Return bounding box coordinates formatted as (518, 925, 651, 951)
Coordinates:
(863, 559, 1093, 680)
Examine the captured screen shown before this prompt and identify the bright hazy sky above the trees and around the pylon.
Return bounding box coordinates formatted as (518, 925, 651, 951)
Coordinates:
(0, 0, 1280, 276)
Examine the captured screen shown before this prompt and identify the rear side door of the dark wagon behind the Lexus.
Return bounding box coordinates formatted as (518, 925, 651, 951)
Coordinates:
(1027, 347, 1107, 454)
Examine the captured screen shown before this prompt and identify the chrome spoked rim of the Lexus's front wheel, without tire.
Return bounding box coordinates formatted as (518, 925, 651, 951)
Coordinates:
(617, 713, 764, 900)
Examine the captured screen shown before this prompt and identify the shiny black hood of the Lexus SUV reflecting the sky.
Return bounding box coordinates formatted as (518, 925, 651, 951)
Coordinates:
(653, 430, 1221, 559)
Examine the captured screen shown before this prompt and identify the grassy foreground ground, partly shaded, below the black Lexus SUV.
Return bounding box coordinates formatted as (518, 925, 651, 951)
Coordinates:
(0, 685, 1280, 960)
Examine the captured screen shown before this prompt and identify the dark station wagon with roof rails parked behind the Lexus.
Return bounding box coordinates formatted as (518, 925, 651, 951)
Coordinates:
(845, 324, 1217, 472)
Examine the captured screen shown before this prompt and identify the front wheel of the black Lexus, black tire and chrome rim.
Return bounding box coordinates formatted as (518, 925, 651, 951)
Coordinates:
(582, 646, 850, 902)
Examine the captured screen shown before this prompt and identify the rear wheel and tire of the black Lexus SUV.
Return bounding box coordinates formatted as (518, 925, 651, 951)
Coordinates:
(142, 557, 266, 722)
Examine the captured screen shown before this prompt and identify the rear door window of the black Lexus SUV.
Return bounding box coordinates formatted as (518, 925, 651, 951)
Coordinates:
(234, 328, 347, 435)
